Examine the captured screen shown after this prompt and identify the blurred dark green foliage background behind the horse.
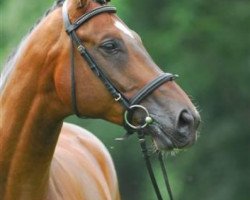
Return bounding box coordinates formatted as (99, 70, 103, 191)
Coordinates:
(0, 0, 250, 200)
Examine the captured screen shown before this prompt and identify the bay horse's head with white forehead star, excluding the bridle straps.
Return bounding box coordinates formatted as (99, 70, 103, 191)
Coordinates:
(55, 0, 200, 149)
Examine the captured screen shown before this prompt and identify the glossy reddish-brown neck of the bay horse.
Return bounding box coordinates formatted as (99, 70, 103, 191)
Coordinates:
(0, 9, 66, 199)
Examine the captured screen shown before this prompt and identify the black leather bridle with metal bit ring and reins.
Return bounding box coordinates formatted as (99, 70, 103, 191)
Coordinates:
(63, 1, 177, 200)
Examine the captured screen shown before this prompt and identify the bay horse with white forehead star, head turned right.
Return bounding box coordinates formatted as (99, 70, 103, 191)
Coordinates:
(0, 0, 200, 200)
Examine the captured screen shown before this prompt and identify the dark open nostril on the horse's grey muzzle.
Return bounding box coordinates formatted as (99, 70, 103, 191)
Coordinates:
(177, 110, 194, 133)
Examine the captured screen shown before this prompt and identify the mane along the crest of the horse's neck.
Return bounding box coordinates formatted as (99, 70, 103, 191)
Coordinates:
(0, 0, 65, 93)
